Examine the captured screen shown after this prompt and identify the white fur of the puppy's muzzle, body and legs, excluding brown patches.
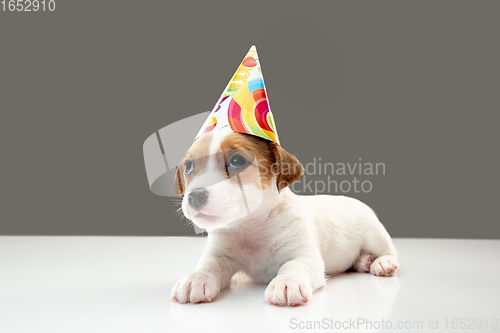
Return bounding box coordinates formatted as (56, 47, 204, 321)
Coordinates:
(172, 132, 398, 306)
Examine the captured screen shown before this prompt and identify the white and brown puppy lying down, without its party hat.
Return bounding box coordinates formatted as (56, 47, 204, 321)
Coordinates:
(172, 133, 398, 306)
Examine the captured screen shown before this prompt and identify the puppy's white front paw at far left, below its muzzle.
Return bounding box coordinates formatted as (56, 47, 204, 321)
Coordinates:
(172, 273, 220, 304)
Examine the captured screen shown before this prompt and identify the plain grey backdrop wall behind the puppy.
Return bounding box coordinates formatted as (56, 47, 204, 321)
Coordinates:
(0, 0, 500, 238)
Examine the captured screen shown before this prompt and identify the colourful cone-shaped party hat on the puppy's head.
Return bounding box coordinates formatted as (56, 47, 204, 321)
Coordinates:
(195, 45, 280, 144)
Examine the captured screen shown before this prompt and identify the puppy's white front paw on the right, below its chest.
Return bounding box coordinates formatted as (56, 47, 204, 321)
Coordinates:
(265, 276, 312, 306)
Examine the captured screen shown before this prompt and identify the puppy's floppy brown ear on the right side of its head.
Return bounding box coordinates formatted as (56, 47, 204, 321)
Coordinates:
(269, 142, 304, 191)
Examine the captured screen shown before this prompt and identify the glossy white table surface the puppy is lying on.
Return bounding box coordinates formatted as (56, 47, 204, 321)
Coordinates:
(0, 236, 500, 333)
